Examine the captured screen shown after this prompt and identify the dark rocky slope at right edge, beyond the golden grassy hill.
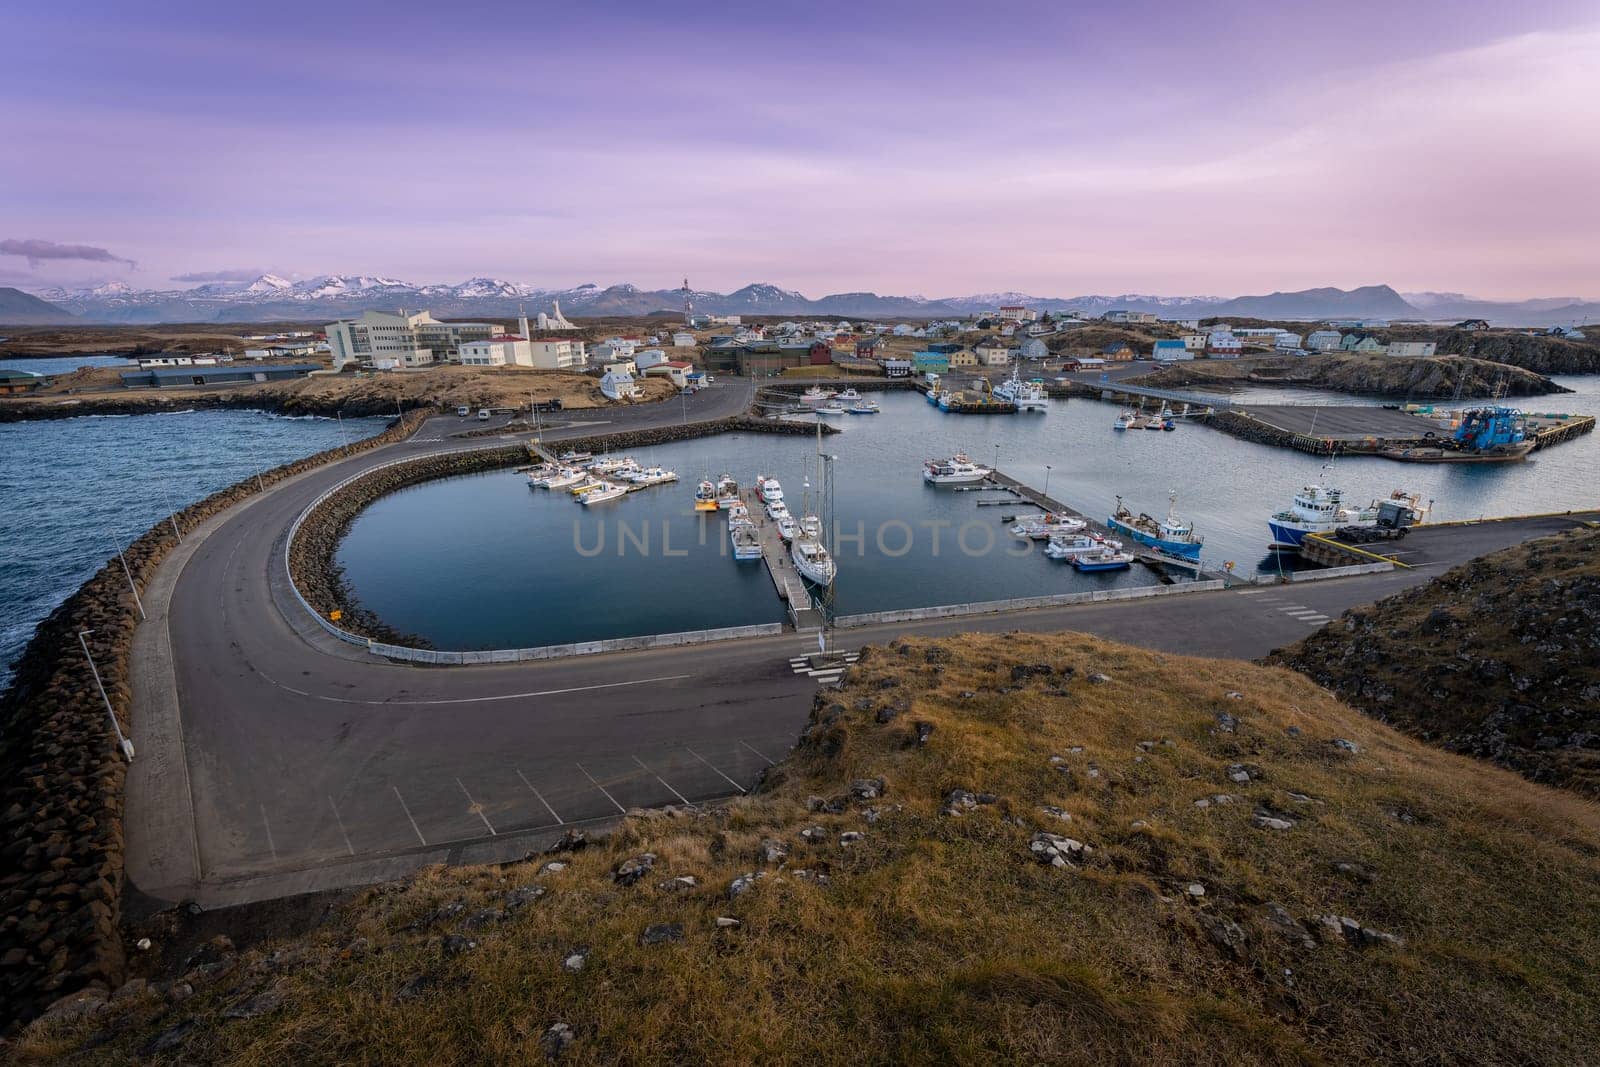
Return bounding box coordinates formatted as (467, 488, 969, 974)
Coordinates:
(1272, 530, 1600, 797)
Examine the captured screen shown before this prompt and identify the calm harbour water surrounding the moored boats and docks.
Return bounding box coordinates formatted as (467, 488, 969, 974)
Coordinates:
(338, 378, 1600, 648)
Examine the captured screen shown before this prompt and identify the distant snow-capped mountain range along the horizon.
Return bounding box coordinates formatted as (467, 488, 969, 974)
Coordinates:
(0, 274, 1600, 326)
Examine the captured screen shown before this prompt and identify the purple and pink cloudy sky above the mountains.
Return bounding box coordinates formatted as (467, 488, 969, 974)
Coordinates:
(0, 0, 1600, 298)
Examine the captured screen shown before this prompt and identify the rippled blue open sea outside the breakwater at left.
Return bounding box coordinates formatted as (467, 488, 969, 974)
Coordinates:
(0, 409, 387, 686)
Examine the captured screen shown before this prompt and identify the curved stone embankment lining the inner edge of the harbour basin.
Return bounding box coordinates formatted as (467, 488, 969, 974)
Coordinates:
(290, 416, 838, 648)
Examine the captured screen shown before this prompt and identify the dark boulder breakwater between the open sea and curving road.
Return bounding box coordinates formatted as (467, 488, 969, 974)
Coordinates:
(0, 413, 424, 1030)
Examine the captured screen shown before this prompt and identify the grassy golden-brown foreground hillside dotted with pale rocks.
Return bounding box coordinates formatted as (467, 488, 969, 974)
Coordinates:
(18, 633, 1600, 1064)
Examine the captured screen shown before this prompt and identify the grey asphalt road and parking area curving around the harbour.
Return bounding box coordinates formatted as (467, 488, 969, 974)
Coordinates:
(126, 381, 1600, 910)
